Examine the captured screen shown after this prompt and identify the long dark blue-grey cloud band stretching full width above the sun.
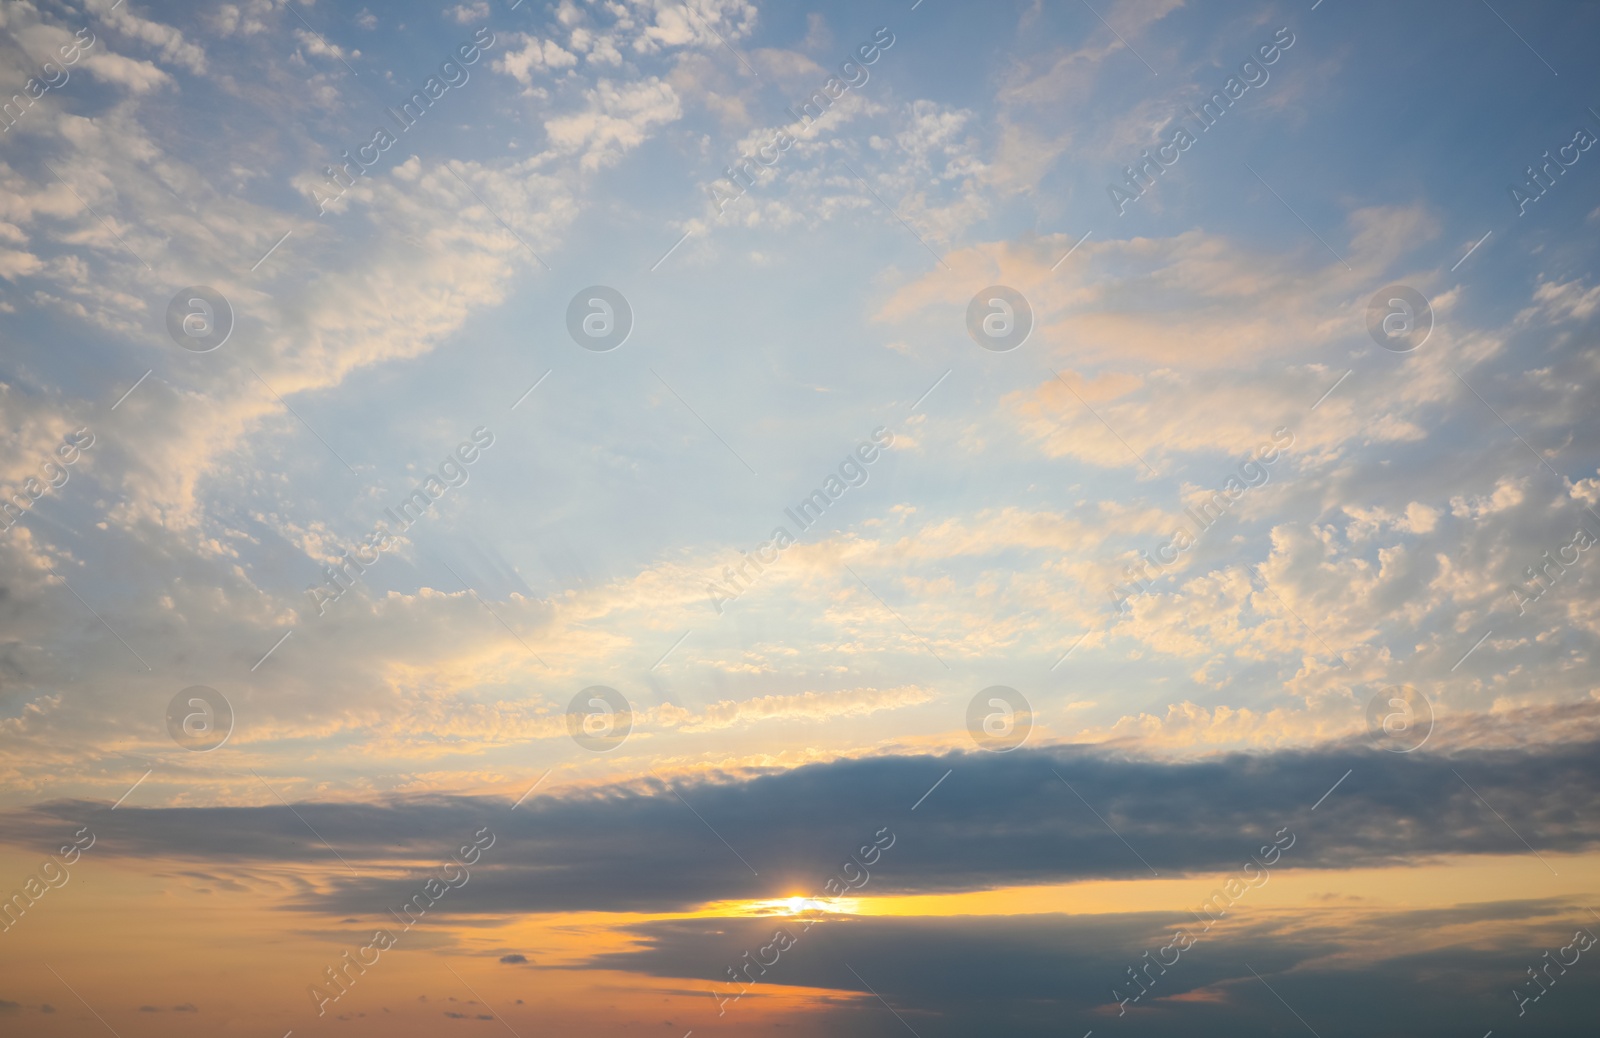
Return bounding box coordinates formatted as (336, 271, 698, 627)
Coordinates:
(0, 729, 1600, 918)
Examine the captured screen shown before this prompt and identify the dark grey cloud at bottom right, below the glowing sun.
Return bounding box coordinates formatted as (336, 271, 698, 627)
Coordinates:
(582, 899, 1600, 1038)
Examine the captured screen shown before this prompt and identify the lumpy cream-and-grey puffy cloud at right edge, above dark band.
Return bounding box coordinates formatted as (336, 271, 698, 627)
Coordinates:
(1088, 454, 1600, 709)
